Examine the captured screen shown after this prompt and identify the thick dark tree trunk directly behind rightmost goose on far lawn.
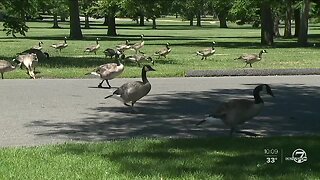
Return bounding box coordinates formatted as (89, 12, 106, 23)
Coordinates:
(260, 1, 274, 46)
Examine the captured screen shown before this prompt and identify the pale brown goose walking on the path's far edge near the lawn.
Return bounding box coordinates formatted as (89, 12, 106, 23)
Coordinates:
(89, 55, 124, 88)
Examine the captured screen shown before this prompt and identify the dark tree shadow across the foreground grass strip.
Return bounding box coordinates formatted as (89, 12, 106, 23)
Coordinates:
(48, 136, 320, 179)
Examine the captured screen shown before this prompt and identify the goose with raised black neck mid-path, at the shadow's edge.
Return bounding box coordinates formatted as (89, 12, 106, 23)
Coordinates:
(105, 65, 155, 110)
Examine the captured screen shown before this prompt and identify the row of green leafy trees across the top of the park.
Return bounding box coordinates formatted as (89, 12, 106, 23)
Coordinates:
(0, 0, 320, 45)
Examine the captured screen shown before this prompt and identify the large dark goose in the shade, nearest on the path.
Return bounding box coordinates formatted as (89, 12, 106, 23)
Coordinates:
(197, 84, 274, 135)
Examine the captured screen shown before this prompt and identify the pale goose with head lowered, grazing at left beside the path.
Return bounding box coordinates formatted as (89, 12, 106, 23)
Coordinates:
(13, 53, 38, 79)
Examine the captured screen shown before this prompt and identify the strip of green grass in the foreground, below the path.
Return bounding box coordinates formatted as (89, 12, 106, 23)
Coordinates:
(0, 136, 320, 180)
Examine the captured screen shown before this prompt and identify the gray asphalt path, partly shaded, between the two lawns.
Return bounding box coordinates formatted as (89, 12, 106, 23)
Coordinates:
(0, 76, 320, 147)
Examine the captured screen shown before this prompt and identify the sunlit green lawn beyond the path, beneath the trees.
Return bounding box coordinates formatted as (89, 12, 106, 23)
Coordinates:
(0, 18, 320, 78)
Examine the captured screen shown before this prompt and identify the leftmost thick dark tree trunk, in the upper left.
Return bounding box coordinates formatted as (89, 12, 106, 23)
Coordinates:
(68, 0, 83, 39)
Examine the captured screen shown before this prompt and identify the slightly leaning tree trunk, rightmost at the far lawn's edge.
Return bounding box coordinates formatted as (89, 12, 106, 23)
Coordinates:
(298, 0, 311, 46)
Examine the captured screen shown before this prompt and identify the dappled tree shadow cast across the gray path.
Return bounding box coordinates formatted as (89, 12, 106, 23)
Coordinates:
(27, 83, 320, 141)
